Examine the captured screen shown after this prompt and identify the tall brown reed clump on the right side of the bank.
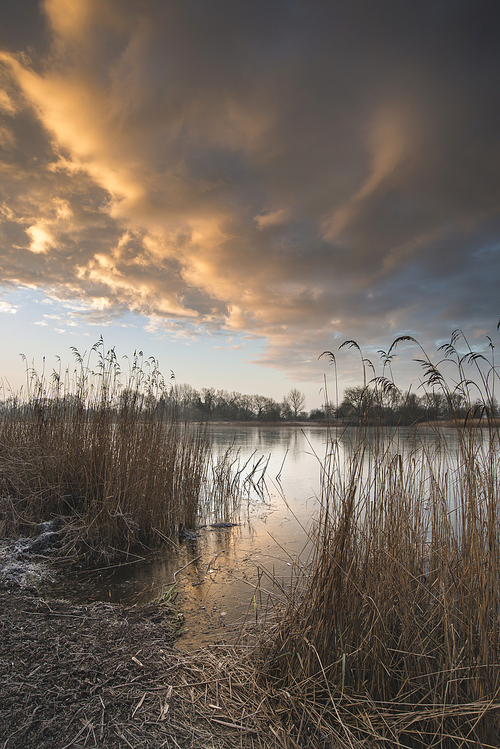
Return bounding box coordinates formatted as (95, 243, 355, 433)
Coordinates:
(265, 337, 500, 747)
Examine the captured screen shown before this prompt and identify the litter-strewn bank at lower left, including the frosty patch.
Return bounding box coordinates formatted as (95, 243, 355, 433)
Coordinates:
(0, 539, 283, 749)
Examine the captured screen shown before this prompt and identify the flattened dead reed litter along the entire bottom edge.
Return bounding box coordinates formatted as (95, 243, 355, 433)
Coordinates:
(0, 592, 499, 749)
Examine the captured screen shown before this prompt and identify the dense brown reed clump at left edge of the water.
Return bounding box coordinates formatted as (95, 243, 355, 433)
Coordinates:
(0, 340, 236, 561)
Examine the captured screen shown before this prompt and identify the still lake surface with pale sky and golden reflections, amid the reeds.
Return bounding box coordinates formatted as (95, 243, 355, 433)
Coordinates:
(63, 425, 476, 647)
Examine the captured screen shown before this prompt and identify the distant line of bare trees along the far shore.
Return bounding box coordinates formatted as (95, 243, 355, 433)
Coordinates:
(0, 382, 500, 426)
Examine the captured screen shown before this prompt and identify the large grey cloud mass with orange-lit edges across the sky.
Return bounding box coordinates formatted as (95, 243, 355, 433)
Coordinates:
(0, 0, 499, 386)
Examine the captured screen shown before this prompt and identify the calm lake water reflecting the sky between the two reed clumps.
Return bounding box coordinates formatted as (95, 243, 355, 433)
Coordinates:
(52, 425, 470, 648)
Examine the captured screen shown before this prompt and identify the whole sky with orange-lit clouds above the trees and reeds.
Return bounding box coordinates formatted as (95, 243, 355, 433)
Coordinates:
(0, 0, 500, 408)
